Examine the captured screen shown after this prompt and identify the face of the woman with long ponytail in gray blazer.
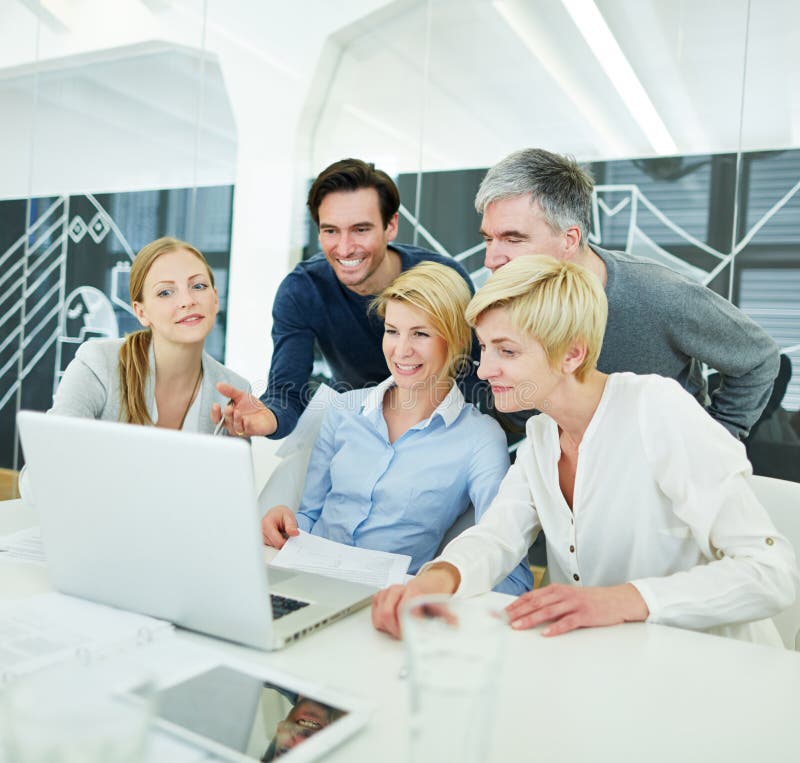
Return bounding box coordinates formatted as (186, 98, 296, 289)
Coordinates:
(133, 249, 219, 344)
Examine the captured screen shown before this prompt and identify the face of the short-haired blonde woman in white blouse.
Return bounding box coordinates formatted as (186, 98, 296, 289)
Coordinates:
(475, 307, 564, 413)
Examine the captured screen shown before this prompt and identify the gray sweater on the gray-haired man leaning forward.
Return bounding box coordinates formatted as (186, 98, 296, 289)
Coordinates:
(498, 246, 779, 438)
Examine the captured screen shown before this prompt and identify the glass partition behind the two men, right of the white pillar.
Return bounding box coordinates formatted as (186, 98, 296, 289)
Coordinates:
(302, 0, 800, 480)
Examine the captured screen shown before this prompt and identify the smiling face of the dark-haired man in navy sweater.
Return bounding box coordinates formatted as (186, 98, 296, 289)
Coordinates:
(319, 188, 397, 294)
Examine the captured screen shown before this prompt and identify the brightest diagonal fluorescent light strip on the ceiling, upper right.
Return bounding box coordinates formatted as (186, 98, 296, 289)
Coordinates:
(561, 0, 678, 154)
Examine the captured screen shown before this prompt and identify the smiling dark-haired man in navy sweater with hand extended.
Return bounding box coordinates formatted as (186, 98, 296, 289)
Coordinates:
(219, 159, 473, 438)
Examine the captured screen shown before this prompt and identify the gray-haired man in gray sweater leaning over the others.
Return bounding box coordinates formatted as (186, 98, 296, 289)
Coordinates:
(475, 148, 778, 439)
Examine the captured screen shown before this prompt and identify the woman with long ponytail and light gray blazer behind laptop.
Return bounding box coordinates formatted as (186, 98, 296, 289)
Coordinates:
(50, 237, 246, 432)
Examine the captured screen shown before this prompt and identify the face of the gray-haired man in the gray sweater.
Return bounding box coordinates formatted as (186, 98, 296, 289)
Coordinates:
(480, 194, 580, 273)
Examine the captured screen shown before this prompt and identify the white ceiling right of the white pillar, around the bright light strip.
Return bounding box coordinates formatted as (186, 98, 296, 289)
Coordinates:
(306, 0, 800, 170)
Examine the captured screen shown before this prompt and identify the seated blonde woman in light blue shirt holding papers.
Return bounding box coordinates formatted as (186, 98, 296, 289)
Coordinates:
(262, 262, 532, 593)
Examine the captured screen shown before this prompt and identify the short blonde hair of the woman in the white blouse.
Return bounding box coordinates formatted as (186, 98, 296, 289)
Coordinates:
(466, 255, 608, 381)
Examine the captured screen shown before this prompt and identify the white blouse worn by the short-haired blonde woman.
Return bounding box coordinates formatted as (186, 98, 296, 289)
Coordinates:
(434, 373, 797, 646)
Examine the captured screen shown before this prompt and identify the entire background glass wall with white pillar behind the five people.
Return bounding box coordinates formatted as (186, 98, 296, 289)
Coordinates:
(0, 0, 800, 479)
